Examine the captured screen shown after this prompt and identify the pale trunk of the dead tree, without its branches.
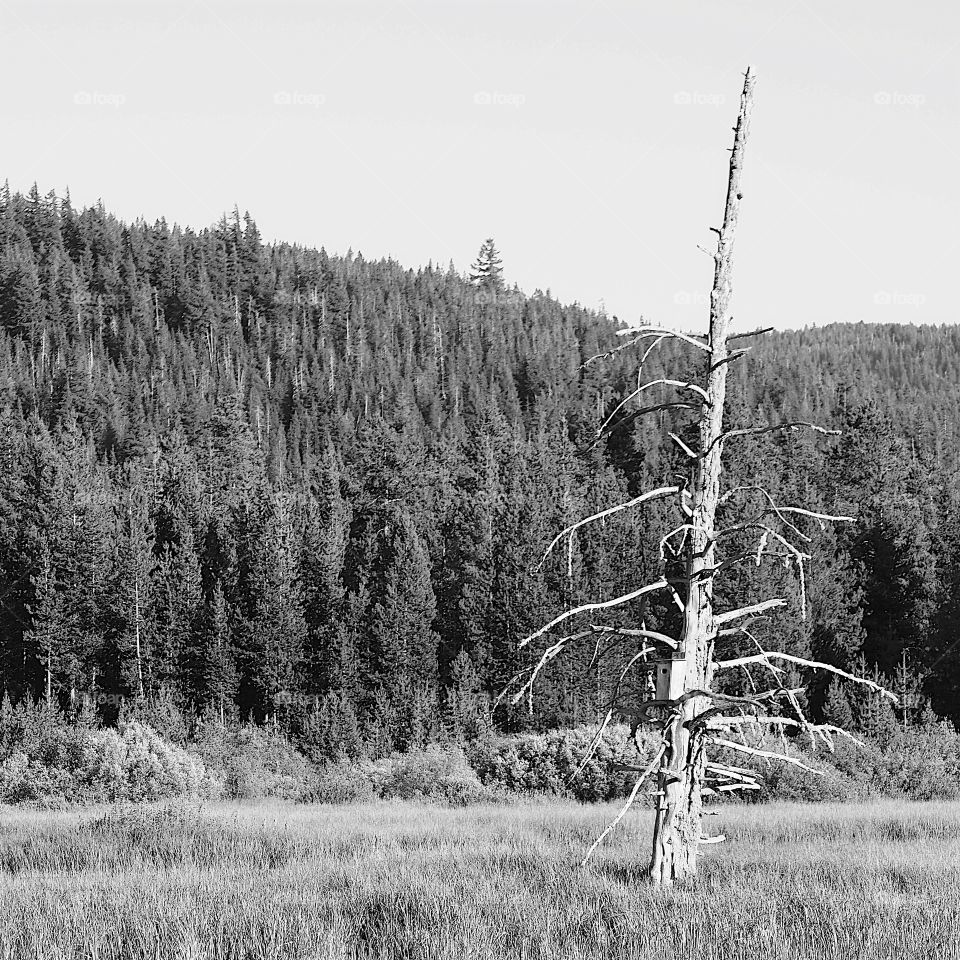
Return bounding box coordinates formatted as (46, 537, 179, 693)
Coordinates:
(650, 68, 755, 884)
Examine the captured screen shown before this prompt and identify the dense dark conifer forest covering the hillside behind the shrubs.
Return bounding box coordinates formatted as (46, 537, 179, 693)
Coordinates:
(0, 182, 960, 754)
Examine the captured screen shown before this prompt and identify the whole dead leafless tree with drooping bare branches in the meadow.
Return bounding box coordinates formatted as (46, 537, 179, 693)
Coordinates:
(513, 68, 892, 884)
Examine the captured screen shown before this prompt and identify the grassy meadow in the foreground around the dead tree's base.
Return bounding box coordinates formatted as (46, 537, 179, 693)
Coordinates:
(0, 802, 960, 960)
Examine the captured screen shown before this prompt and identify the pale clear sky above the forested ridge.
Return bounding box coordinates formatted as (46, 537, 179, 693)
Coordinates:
(0, 0, 960, 330)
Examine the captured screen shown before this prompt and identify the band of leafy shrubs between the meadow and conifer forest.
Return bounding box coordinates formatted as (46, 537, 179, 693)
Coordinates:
(0, 699, 960, 806)
